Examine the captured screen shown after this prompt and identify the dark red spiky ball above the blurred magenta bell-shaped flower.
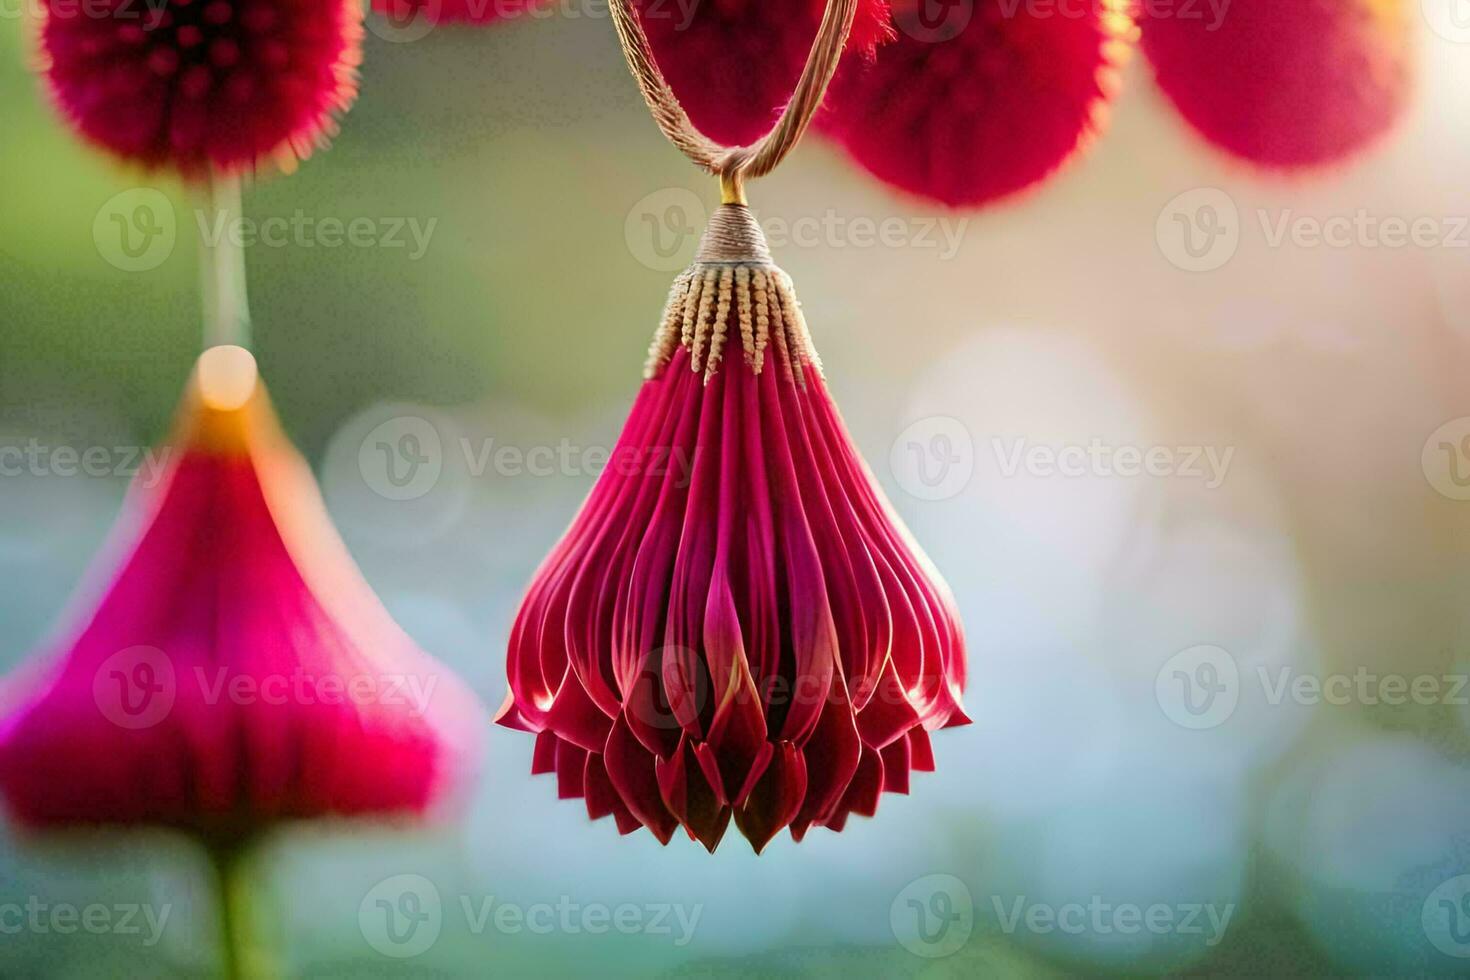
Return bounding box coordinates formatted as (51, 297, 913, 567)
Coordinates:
(41, 0, 362, 178)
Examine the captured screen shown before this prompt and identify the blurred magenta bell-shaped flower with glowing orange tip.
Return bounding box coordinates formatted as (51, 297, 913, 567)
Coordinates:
(0, 347, 479, 839)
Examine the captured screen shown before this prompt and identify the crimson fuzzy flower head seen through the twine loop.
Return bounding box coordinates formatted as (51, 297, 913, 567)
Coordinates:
(634, 0, 891, 145)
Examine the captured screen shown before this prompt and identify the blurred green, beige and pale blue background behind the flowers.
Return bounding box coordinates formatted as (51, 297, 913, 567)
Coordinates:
(0, 4, 1470, 977)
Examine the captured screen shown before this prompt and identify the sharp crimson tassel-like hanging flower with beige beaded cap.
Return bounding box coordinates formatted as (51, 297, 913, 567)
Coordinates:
(498, 204, 967, 851)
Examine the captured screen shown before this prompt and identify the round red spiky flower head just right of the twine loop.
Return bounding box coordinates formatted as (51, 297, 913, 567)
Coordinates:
(817, 0, 1129, 207)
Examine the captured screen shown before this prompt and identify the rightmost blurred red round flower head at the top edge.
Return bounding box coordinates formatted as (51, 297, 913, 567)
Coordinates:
(1139, 0, 1410, 169)
